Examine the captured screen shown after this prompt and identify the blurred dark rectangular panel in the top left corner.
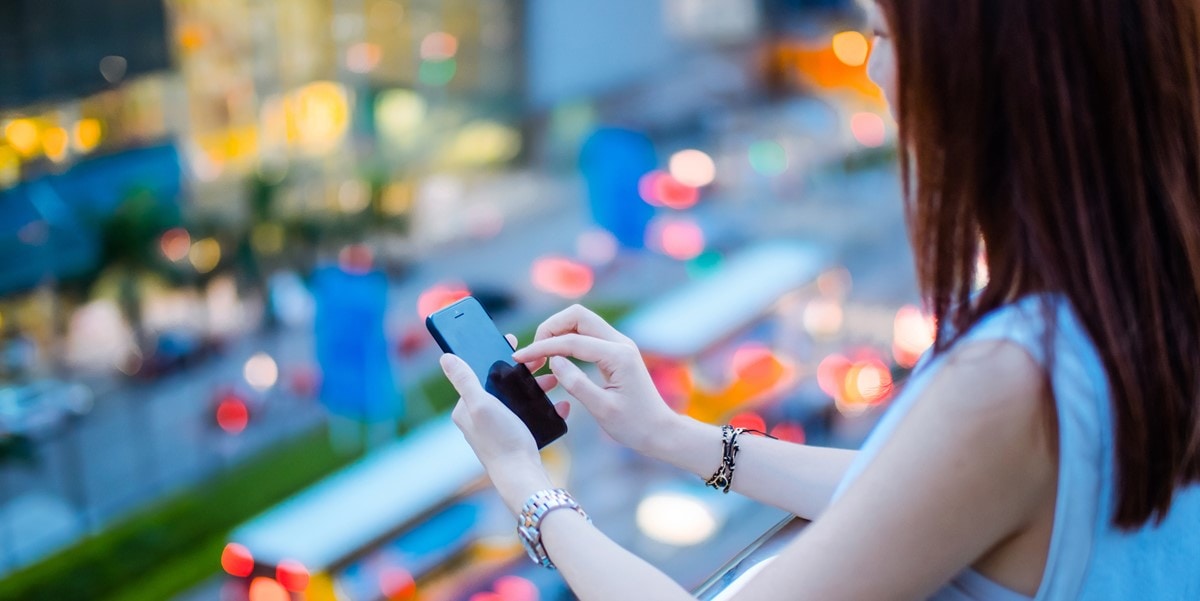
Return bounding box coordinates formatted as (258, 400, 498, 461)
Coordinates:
(0, 0, 169, 108)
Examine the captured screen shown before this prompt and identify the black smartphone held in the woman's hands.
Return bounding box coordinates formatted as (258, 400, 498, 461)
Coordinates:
(425, 296, 566, 449)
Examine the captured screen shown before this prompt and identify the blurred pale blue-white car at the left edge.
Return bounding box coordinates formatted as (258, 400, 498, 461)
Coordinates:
(0, 379, 94, 439)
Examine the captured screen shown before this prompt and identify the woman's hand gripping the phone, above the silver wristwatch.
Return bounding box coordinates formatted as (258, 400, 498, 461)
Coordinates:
(440, 345, 569, 512)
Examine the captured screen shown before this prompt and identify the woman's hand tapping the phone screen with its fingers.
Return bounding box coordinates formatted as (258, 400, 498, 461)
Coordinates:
(512, 305, 680, 452)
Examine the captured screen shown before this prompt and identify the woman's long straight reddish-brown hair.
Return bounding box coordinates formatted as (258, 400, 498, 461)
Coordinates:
(877, 0, 1200, 528)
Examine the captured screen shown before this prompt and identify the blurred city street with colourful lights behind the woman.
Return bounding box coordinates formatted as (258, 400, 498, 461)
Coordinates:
(0, 0, 929, 601)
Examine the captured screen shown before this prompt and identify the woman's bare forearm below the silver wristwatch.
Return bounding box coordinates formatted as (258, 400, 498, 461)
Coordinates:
(541, 510, 694, 601)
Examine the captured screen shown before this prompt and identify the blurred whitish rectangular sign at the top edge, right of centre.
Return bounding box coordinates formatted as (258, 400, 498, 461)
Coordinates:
(664, 0, 758, 43)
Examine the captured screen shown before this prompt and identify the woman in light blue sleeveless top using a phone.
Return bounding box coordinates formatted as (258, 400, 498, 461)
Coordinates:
(443, 0, 1200, 600)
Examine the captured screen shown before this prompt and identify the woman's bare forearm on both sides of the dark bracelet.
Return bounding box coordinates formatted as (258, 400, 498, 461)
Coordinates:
(643, 417, 857, 519)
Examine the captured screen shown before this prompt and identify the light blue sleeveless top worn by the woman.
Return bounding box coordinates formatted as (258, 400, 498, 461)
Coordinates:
(834, 295, 1200, 601)
